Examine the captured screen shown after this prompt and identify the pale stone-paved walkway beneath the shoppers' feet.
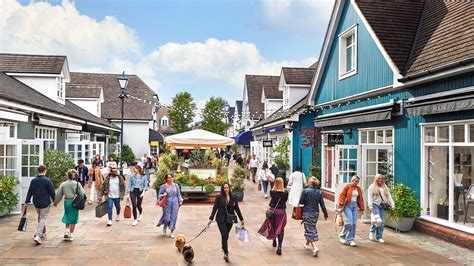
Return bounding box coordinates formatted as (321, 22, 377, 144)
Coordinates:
(0, 175, 466, 265)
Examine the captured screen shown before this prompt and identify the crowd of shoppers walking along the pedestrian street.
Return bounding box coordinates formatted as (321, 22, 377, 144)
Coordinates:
(25, 154, 395, 261)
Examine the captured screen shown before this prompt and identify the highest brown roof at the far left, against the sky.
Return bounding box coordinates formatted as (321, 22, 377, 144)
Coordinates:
(0, 53, 66, 74)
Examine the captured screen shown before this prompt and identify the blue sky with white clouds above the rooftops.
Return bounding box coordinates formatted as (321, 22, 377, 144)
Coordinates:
(0, 0, 334, 110)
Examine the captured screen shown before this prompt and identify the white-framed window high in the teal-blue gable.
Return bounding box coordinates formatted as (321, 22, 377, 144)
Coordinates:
(339, 25, 357, 79)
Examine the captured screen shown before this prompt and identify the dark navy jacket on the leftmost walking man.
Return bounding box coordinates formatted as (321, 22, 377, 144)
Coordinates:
(25, 175, 56, 209)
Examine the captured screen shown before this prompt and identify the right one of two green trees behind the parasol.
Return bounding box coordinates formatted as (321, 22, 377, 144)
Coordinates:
(201, 97, 227, 135)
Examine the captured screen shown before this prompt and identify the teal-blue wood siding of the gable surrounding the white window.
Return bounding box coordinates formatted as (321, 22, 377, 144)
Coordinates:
(315, 1, 393, 104)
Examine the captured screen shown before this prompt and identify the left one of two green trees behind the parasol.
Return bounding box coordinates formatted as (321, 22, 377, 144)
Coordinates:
(168, 92, 196, 133)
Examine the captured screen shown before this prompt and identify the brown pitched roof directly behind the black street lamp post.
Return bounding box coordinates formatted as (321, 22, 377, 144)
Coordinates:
(70, 72, 156, 120)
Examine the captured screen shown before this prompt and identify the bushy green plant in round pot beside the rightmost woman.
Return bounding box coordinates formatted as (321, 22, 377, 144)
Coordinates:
(385, 184, 421, 232)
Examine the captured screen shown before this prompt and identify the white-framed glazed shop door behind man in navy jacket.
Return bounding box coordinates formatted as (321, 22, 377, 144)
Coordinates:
(21, 140, 43, 202)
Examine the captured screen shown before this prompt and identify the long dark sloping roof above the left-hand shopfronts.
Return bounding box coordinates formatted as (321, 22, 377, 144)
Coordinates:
(0, 72, 118, 129)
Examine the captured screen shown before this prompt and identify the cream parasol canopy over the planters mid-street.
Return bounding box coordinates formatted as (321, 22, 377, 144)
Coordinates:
(165, 129, 234, 148)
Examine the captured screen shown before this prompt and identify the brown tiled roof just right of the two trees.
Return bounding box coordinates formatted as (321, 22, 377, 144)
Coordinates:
(245, 75, 281, 120)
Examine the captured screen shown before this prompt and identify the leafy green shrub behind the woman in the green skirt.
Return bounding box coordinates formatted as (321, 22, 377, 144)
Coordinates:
(44, 150, 75, 188)
